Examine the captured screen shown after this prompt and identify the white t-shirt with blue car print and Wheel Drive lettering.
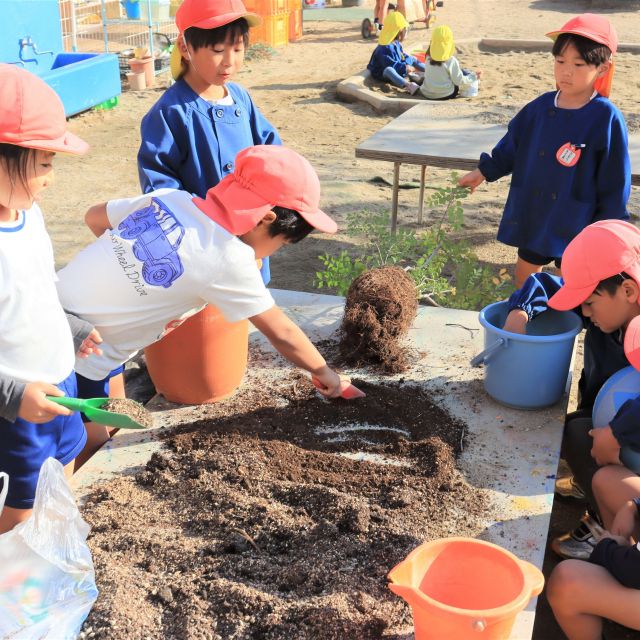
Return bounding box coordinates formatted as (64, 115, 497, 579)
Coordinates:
(58, 189, 274, 380)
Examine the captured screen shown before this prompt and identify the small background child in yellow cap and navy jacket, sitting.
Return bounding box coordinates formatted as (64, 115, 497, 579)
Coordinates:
(367, 11, 424, 95)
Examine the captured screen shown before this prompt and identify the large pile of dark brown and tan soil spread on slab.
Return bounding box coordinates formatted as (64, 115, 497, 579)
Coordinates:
(83, 374, 485, 640)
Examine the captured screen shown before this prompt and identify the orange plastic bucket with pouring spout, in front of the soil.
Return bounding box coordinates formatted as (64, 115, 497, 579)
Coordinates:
(388, 538, 544, 640)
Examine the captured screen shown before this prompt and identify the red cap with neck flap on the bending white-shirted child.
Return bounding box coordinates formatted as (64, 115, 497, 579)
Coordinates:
(193, 145, 338, 235)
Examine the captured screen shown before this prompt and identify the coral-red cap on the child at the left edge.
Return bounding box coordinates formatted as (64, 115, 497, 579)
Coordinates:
(0, 64, 89, 155)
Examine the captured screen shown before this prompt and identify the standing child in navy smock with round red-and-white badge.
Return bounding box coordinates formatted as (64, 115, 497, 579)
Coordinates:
(459, 13, 631, 287)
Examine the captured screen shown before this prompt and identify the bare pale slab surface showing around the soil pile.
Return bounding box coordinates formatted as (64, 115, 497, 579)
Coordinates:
(72, 290, 566, 640)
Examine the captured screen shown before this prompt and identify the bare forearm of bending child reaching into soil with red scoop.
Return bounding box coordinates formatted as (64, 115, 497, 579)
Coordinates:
(249, 306, 340, 398)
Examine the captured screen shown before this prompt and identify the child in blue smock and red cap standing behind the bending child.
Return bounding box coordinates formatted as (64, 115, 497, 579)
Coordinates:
(138, 0, 281, 283)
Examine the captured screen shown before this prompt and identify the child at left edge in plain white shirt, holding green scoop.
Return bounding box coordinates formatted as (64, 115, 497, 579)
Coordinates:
(0, 64, 99, 534)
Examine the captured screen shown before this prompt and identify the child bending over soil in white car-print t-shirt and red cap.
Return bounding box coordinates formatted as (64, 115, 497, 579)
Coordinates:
(58, 145, 350, 456)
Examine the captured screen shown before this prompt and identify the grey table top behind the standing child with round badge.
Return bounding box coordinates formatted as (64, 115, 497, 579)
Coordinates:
(356, 102, 640, 185)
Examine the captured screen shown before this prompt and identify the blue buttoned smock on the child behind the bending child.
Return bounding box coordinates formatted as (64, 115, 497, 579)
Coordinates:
(138, 78, 282, 284)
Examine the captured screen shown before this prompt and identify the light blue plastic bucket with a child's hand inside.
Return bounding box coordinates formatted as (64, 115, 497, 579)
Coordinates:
(471, 301, 582, 409)
